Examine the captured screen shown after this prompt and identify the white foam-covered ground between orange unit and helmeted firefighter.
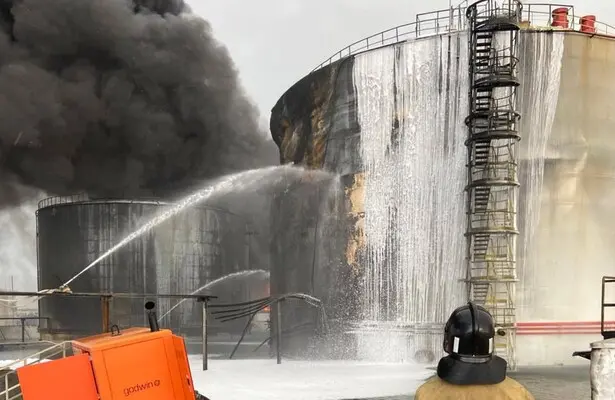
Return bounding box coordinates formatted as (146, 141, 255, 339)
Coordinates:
(190, 356, 434, 400)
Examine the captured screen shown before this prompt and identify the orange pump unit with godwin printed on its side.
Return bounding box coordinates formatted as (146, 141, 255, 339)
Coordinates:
(17, 302, 199, 400)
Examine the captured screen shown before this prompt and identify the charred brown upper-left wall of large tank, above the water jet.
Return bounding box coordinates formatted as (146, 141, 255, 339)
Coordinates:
(270, 58, 361, 176)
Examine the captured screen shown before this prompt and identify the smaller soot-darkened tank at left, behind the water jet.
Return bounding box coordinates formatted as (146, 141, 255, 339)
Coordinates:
(36, 196, 251, 337)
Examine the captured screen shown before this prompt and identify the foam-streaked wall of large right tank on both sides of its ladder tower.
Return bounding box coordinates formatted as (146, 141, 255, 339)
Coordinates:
(271, 16, 615, 365)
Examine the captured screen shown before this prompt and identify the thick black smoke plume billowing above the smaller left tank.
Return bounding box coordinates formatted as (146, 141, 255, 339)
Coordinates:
(0, 0, 275, 205)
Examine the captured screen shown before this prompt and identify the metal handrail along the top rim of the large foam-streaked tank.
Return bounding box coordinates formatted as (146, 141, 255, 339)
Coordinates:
(311, 1, 615, 72)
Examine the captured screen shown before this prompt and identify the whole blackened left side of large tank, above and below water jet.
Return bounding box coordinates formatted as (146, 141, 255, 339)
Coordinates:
(271, 59, 360, 353)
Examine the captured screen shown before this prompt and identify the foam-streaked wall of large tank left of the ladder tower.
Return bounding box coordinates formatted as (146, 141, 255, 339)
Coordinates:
(271, 35, 467, 361)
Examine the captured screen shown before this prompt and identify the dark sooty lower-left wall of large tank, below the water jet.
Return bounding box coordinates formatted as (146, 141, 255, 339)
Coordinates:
(271, 173, 353, 358)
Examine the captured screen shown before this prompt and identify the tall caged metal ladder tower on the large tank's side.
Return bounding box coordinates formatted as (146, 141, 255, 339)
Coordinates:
(465, 0, 521, 370)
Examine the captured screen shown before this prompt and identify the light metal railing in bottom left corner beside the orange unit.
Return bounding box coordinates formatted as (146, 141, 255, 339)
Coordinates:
(0, 341, 72, 400)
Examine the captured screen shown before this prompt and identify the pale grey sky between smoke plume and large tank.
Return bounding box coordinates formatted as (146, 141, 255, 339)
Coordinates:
(187, 0, 615, 126)
